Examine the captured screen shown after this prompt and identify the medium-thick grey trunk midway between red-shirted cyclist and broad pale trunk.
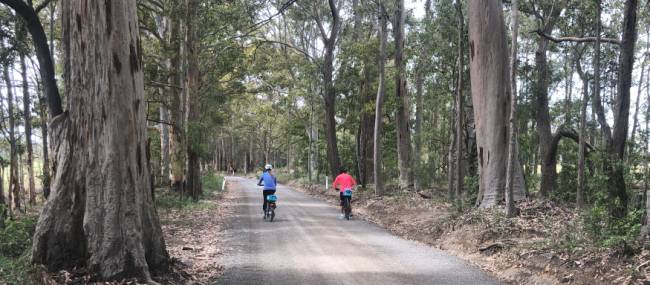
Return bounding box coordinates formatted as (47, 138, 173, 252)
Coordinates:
(393, 0, 413, 188)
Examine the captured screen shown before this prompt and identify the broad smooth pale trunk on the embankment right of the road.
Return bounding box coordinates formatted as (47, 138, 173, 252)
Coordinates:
(469, 0, 524, 207)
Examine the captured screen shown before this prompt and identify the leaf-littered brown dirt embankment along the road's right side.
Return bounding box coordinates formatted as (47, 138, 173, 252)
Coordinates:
(292, 183, 650, 285)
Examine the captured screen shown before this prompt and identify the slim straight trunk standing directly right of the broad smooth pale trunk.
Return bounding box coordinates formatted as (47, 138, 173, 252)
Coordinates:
(506, 0, 519, 218)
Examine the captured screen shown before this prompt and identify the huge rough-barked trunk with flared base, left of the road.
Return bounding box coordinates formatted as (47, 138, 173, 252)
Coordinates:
(32, 1, 169, 280)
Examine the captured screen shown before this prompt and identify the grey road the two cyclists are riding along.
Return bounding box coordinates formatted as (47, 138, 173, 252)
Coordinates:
(217, 177, 499, 285)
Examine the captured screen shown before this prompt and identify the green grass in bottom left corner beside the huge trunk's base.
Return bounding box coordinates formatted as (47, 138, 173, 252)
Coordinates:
(0, 213, 39, 284)
